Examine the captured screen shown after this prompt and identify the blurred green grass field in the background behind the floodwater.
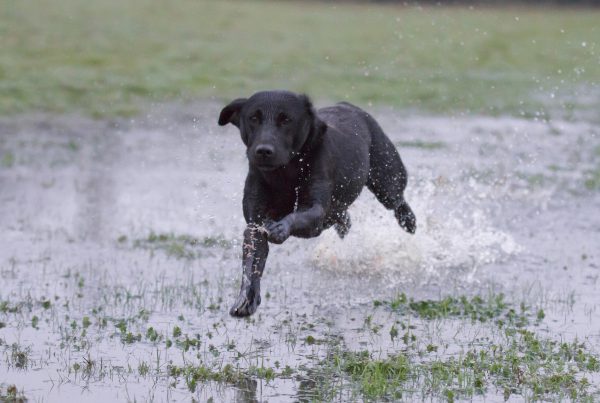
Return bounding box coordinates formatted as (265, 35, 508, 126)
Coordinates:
(0, 0, 600, 116)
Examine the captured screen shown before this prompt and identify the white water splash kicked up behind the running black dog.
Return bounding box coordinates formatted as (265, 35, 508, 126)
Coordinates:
(310, 181, 519, 278)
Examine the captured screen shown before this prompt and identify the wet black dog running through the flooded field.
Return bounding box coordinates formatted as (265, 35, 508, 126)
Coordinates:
(219, 91, 416, 316)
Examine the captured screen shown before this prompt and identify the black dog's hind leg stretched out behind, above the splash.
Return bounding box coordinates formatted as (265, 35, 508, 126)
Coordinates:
(367, 116, 417, 234)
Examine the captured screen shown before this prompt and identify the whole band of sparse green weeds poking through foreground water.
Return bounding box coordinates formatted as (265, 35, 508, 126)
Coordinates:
(0, 282, 600, 402)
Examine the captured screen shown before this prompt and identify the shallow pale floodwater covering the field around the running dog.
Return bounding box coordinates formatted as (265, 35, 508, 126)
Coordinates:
(0, 104, 600, 402)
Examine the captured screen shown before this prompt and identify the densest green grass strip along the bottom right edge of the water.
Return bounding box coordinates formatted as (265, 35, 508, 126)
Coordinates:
(331, 330, 600, 401)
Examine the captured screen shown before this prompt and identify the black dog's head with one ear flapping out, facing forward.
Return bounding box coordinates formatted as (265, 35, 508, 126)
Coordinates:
(219, 91, 325, 171)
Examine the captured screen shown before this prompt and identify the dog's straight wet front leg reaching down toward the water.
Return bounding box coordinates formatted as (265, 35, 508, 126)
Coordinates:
(229, 224, 269, 317)
